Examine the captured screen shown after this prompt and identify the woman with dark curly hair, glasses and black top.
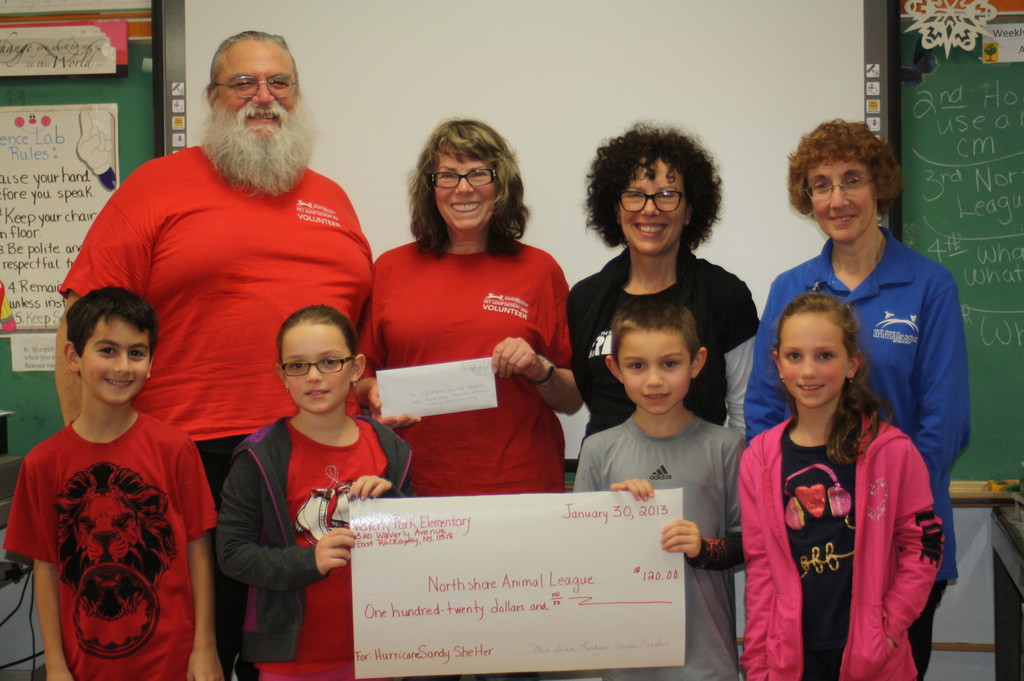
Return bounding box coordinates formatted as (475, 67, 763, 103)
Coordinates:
(568, 124, 758, 435)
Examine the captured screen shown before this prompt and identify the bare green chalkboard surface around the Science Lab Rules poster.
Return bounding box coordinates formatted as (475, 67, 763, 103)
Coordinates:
(0, 45, 154, 455)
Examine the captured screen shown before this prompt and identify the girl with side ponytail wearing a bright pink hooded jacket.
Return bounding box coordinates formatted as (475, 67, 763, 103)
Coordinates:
(739, 292, 942, 681)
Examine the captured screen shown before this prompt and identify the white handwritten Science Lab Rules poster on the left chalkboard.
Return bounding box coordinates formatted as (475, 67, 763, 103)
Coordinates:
(0, 103, 118, 330)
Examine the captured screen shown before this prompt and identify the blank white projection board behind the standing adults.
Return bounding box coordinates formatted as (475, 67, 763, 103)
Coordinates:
(185, 0, 863, 456)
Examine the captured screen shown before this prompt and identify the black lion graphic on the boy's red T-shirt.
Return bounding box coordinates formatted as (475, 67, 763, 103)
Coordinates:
(56, 462, 177, 658)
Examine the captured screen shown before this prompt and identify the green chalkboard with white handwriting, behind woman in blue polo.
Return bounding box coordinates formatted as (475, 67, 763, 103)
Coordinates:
(901, 33, 1024, 480)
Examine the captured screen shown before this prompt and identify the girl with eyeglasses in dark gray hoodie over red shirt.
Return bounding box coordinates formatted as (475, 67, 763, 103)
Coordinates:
(217, 305, 412, 681)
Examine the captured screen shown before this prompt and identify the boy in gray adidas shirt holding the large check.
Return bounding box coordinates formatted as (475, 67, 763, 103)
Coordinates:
(574, 295, 743, 681)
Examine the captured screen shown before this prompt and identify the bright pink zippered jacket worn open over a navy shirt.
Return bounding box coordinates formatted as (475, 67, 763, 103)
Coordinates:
(739, 420, 942, 681)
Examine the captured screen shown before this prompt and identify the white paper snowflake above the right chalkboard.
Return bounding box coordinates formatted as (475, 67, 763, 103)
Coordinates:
(906, 0, 995, 56)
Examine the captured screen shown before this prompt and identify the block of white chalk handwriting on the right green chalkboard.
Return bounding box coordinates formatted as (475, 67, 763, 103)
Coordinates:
(904, 74, 1024, 348)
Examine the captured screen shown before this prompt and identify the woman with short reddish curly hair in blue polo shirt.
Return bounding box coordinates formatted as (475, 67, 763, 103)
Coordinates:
(745, 120, 971, 678)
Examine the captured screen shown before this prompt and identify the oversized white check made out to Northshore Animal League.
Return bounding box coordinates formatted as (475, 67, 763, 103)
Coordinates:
(351, 490, 689, 677)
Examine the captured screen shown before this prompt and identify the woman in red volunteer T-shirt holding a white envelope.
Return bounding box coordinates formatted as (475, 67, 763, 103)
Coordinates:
(356, 120, 583, 497)
